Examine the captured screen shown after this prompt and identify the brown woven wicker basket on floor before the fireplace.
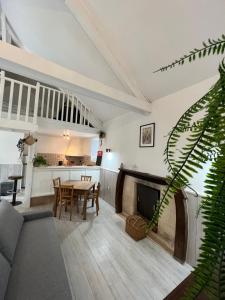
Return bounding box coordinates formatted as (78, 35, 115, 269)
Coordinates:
(125, 215, 147, 241)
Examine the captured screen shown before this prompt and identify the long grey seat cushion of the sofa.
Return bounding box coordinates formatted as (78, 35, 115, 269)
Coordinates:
(5, 218, 72, 300)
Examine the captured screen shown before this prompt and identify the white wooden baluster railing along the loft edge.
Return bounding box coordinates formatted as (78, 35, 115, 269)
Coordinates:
(0, 71, 102, 132)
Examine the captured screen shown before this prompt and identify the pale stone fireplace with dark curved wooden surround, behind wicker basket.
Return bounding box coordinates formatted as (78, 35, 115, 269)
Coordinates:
(115, 167, 188, 262)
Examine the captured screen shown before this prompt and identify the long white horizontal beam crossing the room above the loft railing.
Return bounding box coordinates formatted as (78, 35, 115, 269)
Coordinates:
(0, 42, 151, 114)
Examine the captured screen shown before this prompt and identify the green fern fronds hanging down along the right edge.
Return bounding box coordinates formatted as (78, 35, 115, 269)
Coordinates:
(149, 35, 225, 300)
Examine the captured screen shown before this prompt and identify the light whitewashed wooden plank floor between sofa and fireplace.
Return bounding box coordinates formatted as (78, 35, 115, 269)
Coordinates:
(48, 200, 191, 300)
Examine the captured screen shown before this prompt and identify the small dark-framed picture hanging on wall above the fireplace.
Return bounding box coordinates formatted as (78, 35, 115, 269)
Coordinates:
(139, 123, 155, 147)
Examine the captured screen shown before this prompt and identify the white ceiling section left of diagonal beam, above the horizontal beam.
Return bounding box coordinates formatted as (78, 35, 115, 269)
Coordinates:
(2, 0, 128, 91)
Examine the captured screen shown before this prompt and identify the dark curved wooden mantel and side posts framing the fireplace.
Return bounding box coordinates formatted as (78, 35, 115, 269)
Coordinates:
(115, 168, 188, 263)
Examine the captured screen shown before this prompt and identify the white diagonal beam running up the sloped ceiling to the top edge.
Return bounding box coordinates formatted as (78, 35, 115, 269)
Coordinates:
(65, 0, 147, 101)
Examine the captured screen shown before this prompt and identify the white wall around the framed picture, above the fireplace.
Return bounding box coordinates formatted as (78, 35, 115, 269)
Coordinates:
(102, 77, 217, 194)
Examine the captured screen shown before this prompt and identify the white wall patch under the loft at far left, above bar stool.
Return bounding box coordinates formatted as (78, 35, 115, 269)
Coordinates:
(0, 130, 24, 164)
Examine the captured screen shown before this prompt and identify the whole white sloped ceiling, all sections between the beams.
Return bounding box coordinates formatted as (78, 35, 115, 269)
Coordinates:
(2, 0, 225, 120)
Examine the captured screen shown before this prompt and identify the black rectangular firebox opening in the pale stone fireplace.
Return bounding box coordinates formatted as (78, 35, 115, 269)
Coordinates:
(137, 183, 160, 220)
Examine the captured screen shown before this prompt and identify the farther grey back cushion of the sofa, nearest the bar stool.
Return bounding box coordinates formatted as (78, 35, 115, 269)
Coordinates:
(0, 201, 23, 263)
